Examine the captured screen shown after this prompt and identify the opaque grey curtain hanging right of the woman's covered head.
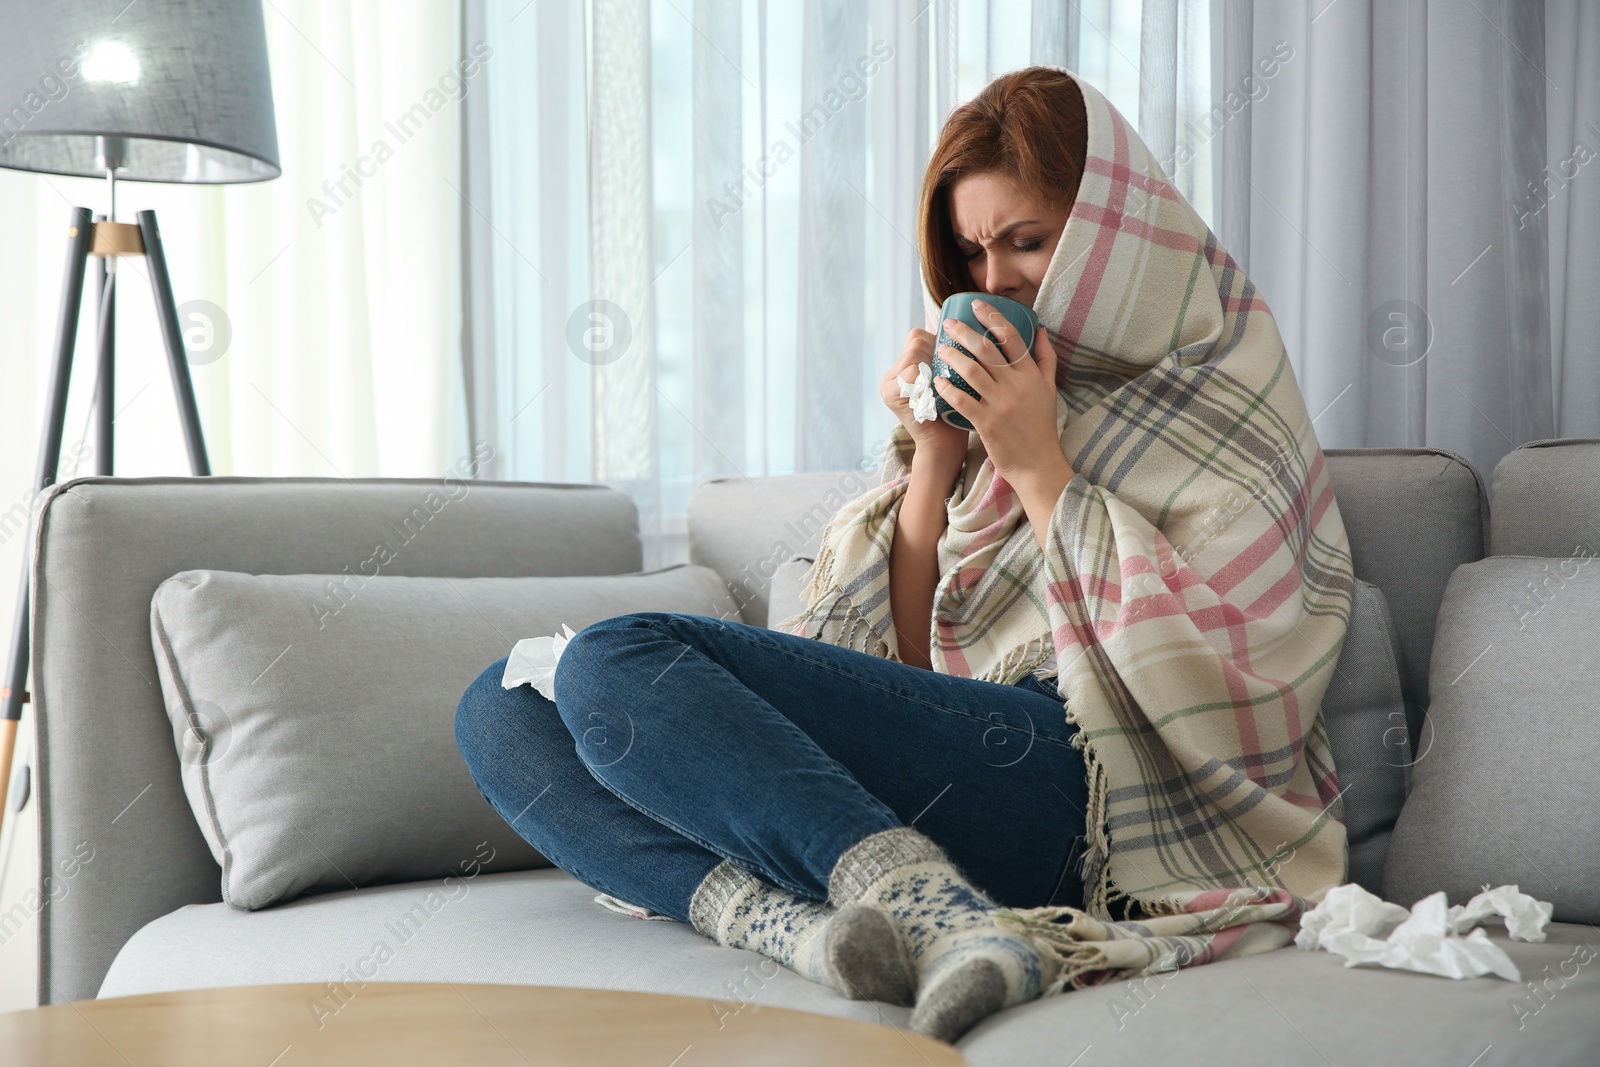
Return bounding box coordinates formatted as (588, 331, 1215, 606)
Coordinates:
(1211, 0, 1600, 489)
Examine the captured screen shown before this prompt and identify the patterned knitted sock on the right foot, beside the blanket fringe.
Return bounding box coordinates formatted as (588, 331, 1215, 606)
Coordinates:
(829, 827, 1054, 1043)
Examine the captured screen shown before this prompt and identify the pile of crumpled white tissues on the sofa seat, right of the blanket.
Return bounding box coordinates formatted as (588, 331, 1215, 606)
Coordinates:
(1294, 883, 1555, 982)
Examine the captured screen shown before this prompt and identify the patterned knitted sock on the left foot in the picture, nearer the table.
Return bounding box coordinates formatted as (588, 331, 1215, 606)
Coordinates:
(690, 861, 917, 1008)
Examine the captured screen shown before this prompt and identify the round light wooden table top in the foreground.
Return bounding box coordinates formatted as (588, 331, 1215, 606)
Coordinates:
(0, 982, 966, 1067)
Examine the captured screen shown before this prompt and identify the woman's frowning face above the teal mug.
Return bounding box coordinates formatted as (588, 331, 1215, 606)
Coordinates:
(950, 171, 1067, 307)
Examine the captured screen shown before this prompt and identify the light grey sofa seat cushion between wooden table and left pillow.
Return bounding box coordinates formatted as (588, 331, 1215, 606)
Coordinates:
(99, 869, 910, 1025)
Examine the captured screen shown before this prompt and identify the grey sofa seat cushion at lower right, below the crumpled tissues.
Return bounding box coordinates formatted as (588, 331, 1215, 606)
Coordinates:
(962, 923, 1600, 1067)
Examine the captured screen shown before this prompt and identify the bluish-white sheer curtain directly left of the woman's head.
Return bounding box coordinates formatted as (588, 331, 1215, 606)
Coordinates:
(464, 0, 1184, 565)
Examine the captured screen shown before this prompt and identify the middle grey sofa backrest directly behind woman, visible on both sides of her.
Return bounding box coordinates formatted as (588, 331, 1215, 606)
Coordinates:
(688, 448, 1490, 755)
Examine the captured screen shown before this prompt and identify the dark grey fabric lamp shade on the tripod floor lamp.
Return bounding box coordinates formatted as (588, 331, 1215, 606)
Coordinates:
(0, 0, 282, 184)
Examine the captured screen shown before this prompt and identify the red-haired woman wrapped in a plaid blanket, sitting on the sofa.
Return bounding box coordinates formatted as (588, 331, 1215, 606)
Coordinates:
(456, 67, 1352, 1041)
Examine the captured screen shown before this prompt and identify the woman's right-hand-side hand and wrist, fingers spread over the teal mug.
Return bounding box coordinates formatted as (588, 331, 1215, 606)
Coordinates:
(933, 301, 1074, 544)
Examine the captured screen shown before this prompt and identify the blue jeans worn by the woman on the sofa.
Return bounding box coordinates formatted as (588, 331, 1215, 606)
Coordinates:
(456, 611, 1088, 921)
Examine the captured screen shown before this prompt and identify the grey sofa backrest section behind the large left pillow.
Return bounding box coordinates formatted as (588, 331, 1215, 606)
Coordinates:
(30, 478, 642, 1003)
